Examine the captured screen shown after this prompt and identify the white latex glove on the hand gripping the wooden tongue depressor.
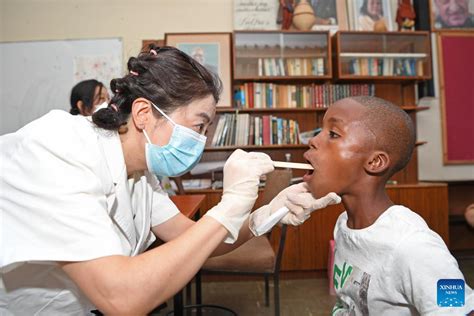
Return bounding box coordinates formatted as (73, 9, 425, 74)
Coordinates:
(205, 149, 274, 243)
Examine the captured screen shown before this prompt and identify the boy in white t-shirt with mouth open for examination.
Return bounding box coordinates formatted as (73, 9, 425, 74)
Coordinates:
(304, 97, 474, 316)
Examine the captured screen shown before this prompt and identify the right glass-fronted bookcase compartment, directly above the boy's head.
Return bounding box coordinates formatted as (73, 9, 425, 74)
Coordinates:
(332, 31, 431, 81)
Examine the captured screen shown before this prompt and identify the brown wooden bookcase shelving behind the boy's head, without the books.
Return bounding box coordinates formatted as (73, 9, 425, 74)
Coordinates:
(198, 31, 431, 184)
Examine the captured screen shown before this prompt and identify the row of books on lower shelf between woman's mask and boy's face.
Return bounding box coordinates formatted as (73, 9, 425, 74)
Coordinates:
(211, 113, 299, 147)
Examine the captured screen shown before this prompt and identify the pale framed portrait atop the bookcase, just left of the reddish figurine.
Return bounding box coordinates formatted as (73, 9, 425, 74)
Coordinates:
(348, 0, 396, 31)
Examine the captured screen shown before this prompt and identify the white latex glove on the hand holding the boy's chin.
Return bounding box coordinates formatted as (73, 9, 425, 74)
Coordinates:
(249, 182, 341, 236)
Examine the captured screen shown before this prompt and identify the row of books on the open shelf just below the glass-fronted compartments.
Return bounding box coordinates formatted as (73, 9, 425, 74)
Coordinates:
(234, 82, 375, 109)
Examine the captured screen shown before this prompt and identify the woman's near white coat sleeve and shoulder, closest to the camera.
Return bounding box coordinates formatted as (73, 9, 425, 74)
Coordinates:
(0, 111, 122, 267)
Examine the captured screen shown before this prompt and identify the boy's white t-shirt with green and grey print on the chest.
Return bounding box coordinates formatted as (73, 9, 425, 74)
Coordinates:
(332, 205, 474, 316)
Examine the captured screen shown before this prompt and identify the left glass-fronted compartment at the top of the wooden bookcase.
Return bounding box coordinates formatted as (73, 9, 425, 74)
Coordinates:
(233, 31, 332, 81)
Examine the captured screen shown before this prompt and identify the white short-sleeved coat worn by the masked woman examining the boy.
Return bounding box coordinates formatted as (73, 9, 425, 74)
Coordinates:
(0, 110, 179, 315)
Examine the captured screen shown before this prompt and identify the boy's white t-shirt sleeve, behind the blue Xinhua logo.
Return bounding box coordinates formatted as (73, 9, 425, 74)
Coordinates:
(394, 230, 474, 315)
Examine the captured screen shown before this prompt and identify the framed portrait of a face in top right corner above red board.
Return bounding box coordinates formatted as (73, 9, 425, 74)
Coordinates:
(429, 0, 474, 32)
